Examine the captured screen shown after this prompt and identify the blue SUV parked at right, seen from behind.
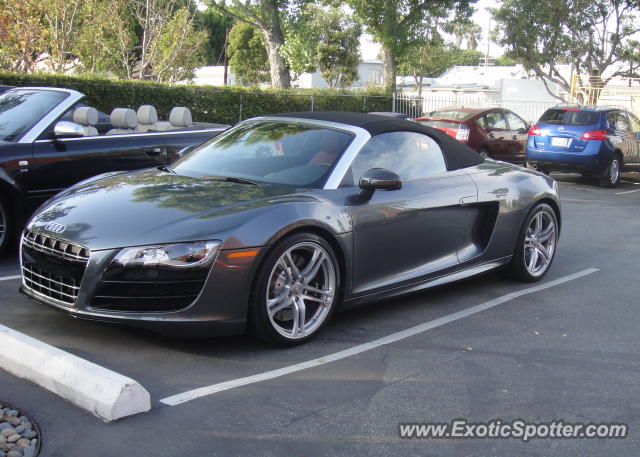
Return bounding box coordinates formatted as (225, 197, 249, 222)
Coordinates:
(527, 106, 640, 187)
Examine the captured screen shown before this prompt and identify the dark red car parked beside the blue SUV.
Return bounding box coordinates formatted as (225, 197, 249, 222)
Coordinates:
(416, 108, 529, 164)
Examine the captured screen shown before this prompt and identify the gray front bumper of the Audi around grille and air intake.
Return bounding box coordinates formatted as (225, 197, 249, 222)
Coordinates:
(20, 244, 264, 337)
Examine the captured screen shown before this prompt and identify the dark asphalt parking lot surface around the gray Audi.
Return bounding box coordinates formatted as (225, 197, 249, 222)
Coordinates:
(0, 173, 640, 457)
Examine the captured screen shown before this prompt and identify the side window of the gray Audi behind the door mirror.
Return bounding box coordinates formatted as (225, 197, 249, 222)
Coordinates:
(347, 132, 447, 184)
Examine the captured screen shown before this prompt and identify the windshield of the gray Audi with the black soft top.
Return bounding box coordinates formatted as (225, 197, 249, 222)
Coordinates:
(172, 121, 353, 188)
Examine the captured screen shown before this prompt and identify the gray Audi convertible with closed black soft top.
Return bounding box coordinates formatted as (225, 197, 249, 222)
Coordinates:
(20, 112, 560, 345)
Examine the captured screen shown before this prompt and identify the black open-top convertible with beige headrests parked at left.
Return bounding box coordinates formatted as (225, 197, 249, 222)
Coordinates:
(0, 87, 228, 252)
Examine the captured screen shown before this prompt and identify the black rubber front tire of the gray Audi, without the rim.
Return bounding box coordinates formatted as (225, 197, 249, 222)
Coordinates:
(248, 232, 341, 347)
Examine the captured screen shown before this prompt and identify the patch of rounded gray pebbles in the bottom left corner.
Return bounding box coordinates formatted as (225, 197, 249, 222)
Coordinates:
(0, 402, 40, 457)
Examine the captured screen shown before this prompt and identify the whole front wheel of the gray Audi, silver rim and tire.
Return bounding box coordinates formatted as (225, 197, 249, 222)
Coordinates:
(249, 233, 340, 346)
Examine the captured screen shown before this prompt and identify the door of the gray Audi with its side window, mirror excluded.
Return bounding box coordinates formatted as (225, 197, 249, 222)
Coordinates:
(347, 132, 477, 294)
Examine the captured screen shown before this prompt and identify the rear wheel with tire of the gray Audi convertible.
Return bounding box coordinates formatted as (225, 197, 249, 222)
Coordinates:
(509, 203, 558, 282)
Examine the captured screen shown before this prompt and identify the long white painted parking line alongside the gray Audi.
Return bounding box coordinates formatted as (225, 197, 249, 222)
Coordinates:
(160, 268, 598, 406)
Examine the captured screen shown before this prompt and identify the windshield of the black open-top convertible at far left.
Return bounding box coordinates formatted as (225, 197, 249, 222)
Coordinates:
(0, 89, 68, 141)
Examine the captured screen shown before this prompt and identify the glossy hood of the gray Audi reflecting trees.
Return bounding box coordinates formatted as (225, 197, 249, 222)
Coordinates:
(28, 169, 314, 250)
